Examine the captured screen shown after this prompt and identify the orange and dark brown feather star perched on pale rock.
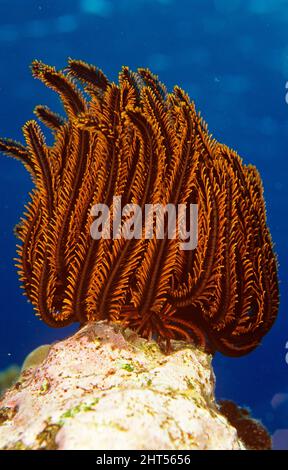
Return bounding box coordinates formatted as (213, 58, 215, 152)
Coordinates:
(0, 60, 278, 356)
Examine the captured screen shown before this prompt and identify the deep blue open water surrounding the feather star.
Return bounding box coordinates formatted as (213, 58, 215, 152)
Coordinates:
(0, 0, 288, 449)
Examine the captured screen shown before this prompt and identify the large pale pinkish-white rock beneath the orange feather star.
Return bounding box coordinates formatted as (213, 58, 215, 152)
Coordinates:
(0, 322, 245, 450)
